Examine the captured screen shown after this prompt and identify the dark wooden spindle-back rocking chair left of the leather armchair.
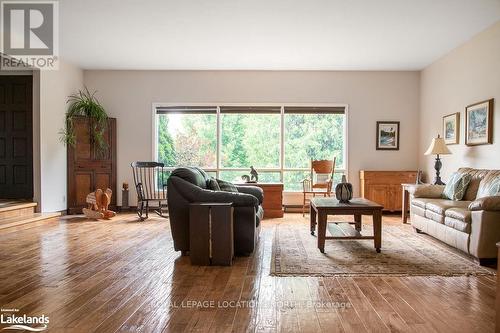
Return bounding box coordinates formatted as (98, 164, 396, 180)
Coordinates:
(130, 162, 168, 221)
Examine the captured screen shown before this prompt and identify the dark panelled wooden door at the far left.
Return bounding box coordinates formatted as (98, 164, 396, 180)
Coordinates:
(0, 75, 33, 200)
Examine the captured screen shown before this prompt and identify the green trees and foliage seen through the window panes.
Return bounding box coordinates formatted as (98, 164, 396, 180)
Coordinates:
(158, 114, 344, 191)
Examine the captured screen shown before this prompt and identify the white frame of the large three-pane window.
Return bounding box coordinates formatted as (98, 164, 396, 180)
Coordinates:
(151, 103, 349, 193)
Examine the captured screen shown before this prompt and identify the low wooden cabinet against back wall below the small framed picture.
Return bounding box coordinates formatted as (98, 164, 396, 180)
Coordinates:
(359, 170, 417, 211)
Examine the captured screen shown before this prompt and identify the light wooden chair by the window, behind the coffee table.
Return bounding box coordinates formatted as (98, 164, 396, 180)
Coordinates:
(302, 157, 336, 216)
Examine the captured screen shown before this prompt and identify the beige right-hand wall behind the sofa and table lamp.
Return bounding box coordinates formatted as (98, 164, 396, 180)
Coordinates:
(418, 22, 500, 181)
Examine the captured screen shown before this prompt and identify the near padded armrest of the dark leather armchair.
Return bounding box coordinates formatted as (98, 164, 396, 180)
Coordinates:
(168, 176, 259, 207)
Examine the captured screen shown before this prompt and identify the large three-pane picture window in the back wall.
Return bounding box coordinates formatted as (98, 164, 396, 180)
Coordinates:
(155, 106, 347, 192)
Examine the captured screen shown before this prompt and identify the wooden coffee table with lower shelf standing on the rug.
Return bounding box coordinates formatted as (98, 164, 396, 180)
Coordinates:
(310, 197, 384, 253)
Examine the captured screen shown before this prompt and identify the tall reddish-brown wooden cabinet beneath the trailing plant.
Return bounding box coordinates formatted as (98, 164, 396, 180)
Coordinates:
(68, 117, 116, 214)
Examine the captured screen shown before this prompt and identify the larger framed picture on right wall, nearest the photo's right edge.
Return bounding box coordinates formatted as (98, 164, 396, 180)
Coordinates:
(465, 98, 493, 146)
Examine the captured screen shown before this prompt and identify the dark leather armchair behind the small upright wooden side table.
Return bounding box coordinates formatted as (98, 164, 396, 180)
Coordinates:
(167, 167, 264, 255)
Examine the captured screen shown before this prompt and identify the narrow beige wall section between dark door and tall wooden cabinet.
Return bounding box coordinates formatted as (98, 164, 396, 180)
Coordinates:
(39, 61, 83, 212)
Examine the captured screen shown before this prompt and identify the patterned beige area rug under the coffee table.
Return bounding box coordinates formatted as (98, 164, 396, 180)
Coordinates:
(271, 219, 495, 276)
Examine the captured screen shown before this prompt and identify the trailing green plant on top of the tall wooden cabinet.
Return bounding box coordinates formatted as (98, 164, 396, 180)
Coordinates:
(60, 87, 108, 153)
